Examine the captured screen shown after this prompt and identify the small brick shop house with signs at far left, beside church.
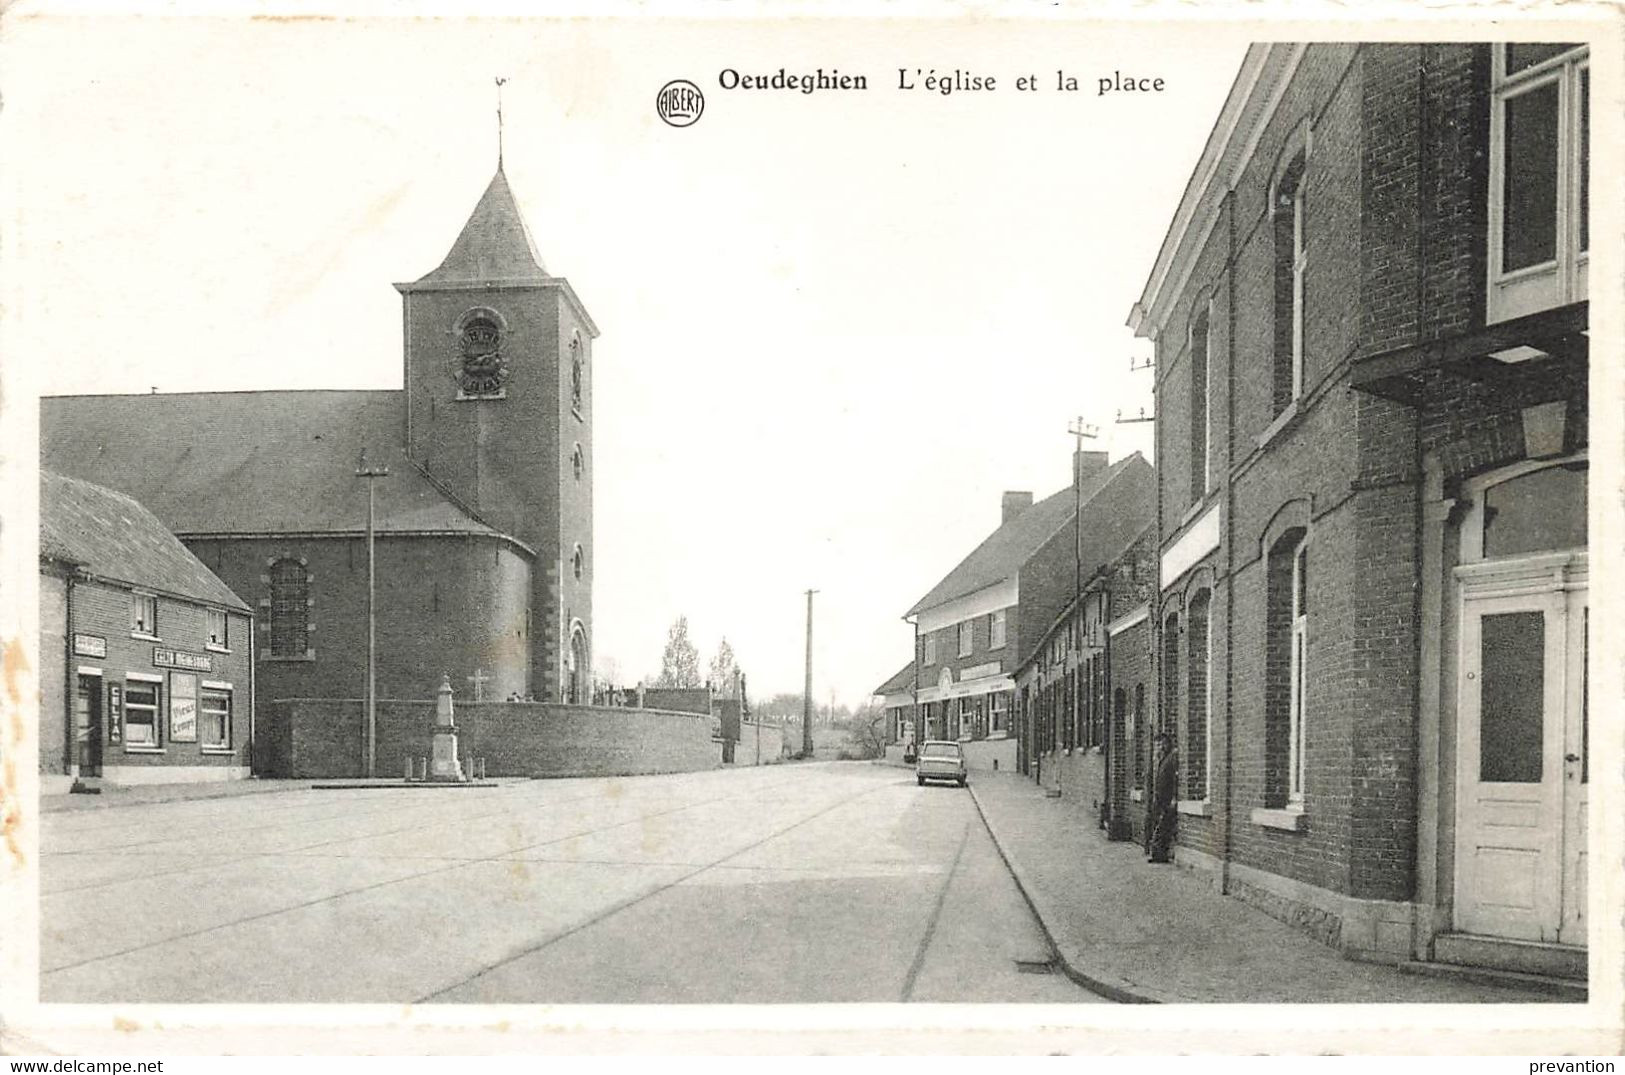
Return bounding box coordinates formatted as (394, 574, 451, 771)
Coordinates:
(39, 471, 254, 792)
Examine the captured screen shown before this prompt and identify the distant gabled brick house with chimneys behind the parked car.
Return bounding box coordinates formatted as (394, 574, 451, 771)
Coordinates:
(904, 451, 1154, 770)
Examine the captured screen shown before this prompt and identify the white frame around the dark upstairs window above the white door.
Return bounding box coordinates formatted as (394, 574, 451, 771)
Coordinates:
(1485, 44, 1591, 325)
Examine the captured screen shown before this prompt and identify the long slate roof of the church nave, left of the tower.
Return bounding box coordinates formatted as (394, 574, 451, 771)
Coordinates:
(39, 391, 513, 548)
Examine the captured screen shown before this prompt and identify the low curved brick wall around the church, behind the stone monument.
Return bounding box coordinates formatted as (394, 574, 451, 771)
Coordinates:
(254, 698, 724, 779)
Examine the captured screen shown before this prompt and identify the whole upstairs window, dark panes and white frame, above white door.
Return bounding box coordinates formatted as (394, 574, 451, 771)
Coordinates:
(1489, 44, 1591, 323)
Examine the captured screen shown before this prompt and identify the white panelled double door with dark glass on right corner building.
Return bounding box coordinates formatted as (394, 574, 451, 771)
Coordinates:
(1456, 589, 1586, 945)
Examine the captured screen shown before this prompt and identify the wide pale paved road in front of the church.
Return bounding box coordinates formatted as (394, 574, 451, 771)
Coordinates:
(41, 763, 1100, 1004)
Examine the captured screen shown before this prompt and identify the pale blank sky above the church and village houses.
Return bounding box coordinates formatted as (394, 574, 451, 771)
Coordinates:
(0, 18, 1248, 703)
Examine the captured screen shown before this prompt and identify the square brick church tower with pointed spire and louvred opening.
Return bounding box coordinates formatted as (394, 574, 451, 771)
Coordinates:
(395, 162, 598, 703)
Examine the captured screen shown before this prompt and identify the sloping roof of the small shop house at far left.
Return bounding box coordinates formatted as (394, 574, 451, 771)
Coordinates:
(39, 471, 249, 612)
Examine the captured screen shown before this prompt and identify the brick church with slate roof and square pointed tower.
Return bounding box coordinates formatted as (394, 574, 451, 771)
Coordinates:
(41, 162, 598, 702)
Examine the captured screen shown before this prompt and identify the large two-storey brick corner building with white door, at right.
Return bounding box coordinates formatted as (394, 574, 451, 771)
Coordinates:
(1129, 44, 1589, 976)
